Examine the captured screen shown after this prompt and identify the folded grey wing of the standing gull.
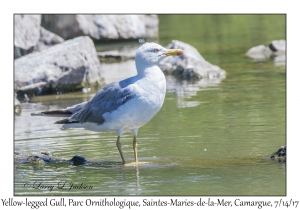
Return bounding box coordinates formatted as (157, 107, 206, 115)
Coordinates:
(67, 82, 135, 124)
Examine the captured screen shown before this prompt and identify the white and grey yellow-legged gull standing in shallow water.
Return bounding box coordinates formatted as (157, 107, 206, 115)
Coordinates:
(31, 43, 183, 164)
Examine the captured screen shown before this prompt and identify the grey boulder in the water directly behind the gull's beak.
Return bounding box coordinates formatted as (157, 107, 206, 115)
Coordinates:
(159, 40, 226, 79)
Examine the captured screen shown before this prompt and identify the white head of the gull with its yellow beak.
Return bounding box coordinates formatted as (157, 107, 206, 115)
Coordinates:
(135, 42, 183, 66)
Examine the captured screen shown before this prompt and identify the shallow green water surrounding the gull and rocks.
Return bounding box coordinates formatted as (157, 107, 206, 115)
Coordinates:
(15, 15, 286, 195)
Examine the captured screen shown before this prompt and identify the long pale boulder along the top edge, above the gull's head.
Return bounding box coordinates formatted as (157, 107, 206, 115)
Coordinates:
(42, 15, 159, 40)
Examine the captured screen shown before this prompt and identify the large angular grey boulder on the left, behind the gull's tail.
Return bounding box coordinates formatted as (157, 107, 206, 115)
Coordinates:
(14, 36, 102, 95)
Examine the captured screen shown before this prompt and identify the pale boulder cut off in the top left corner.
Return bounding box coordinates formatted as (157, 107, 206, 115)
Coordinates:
(14, 15, 41, 58)
